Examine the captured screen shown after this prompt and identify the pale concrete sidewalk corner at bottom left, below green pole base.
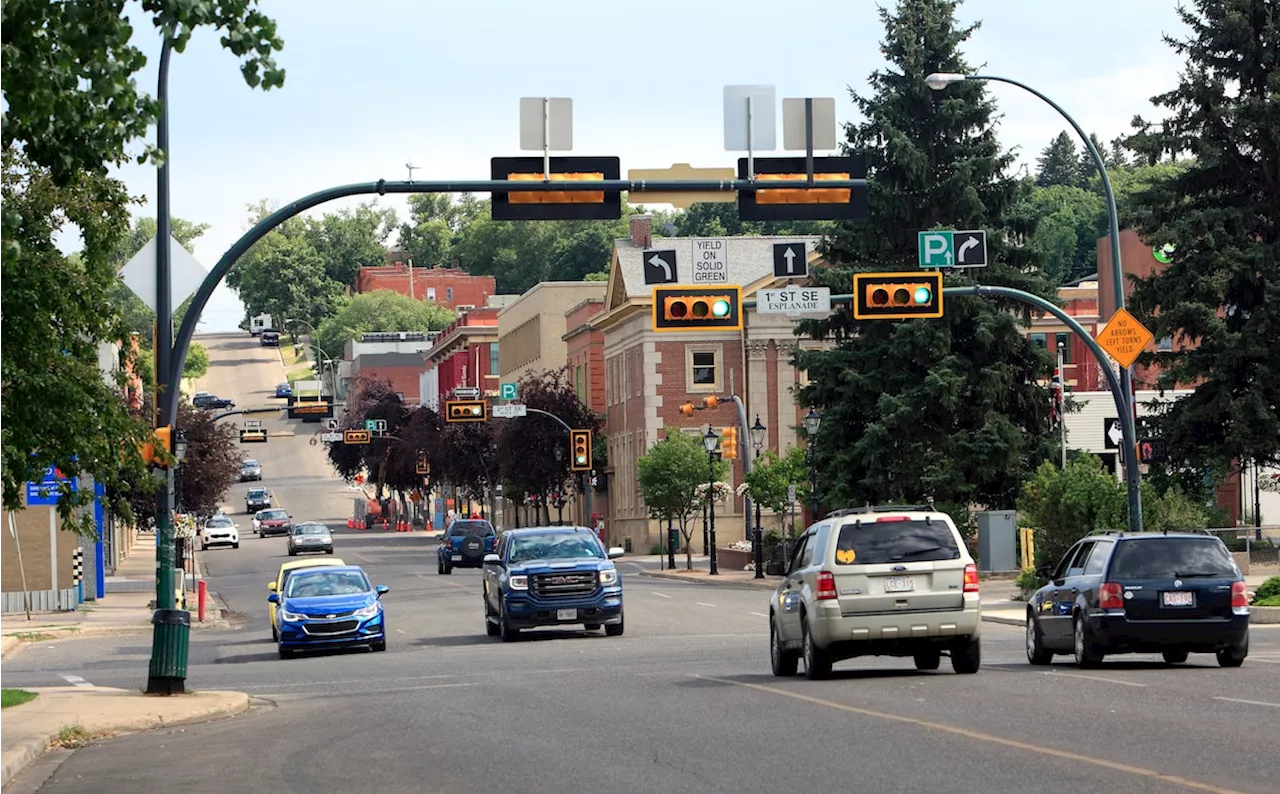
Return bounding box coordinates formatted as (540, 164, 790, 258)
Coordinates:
(0, 686, 250, 789)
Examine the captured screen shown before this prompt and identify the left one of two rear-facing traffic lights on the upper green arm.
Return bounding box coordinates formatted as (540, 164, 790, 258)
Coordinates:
(489, 158, 622, 220)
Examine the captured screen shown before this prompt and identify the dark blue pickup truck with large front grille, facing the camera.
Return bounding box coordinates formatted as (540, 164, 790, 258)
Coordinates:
(484, 526, 623, 642)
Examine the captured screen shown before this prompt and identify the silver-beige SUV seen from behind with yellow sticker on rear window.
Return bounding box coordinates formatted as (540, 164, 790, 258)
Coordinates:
(767, 506, 982, 679)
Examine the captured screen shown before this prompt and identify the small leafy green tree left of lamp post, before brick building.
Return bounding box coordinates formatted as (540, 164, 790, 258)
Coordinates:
(636, 428, 728, 570)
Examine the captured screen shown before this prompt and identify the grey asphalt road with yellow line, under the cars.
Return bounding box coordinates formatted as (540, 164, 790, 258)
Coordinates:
(0, 332, 1280, 794)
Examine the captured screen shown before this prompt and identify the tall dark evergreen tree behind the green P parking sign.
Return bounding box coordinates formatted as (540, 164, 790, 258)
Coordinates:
(797, 0, 1051, 506)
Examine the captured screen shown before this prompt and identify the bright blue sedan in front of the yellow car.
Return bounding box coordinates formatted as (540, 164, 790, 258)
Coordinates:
(266, 565, 390, 658)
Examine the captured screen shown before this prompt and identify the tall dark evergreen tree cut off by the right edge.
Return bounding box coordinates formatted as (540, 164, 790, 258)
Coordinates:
(1128, 0, 1280, 471)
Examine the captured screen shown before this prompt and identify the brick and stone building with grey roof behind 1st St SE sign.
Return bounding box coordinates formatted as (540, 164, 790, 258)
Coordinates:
(591, 215, 826, 551)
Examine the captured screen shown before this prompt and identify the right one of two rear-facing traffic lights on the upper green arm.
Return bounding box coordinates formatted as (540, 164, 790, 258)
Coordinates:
(737, 154, 868, 220)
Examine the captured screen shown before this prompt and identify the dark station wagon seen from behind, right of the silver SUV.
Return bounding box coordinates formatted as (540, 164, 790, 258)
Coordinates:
(1027, 530, 1249, 667)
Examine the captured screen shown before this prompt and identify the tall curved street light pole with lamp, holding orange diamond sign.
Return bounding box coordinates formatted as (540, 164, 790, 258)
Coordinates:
(924, 72, 1142, 531)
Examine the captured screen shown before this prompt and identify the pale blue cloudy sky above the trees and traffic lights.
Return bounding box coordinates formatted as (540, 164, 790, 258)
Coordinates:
(92, 0, 1185, 332)
